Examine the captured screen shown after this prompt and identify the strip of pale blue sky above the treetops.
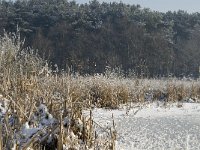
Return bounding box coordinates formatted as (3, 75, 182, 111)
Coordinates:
(73, 0, 200, 13)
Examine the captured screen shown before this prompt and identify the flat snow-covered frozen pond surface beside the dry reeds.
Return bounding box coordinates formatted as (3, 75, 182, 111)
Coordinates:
(86, 103, 200, 150)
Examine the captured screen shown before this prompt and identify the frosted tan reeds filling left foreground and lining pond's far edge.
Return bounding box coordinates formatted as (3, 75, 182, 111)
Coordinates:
(0, 33, 200, 149)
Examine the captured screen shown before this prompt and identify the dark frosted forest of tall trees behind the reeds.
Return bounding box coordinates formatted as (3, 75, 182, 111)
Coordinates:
(0, 0, 200, 77)
